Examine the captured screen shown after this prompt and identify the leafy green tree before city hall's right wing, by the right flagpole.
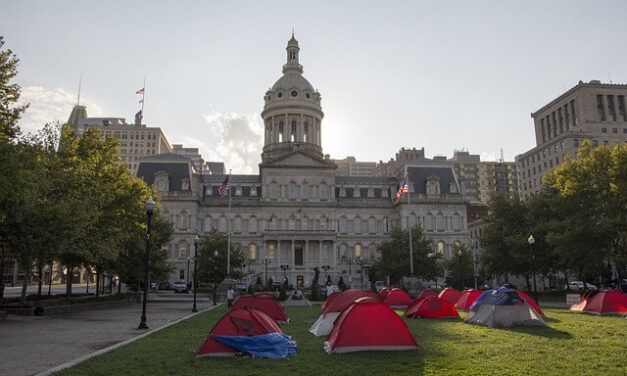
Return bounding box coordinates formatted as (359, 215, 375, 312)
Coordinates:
(370, 225, 441, 283)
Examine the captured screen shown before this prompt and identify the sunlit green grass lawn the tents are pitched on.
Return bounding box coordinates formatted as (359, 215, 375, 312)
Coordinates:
(55, 306, 627, 376)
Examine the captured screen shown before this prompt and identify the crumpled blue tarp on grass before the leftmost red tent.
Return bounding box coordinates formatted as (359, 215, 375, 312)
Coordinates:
(211, 333, 296, 359)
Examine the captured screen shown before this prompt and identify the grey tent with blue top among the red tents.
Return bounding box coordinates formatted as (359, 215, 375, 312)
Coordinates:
(464, 287, 546, 328)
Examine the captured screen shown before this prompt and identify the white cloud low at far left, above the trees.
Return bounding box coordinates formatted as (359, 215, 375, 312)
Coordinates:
(19, 86, 103, 133)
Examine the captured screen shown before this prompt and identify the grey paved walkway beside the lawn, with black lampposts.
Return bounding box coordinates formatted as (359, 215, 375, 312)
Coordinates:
(0, 302, 216, 376)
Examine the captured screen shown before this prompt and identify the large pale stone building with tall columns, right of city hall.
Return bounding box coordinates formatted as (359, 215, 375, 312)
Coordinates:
(516, 80, 627, 199)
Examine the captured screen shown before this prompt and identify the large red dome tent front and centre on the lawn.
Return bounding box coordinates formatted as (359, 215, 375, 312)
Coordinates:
(324, 302, 418, 354)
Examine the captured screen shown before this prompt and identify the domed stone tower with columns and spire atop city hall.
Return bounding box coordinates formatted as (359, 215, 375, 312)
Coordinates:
(261, 34, 324, 163)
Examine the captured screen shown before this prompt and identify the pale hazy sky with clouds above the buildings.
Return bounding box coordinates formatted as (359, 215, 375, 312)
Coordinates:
(0, 0, 627, 173)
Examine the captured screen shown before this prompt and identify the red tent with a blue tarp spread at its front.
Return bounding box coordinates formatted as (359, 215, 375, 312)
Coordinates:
(196, 308, 282, 358)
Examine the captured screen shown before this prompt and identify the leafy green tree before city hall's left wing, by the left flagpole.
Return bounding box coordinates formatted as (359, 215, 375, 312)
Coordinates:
(197, 230, 246, 284)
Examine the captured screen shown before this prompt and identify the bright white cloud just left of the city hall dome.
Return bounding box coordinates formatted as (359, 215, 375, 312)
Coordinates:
(199, 111, 263, 174)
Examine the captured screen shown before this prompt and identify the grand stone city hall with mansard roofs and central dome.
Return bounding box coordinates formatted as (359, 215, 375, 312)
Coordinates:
(137, 36, 469, 287)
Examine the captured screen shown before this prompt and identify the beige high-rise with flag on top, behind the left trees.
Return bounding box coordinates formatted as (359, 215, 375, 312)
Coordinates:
(68, 105, 172, 174)
